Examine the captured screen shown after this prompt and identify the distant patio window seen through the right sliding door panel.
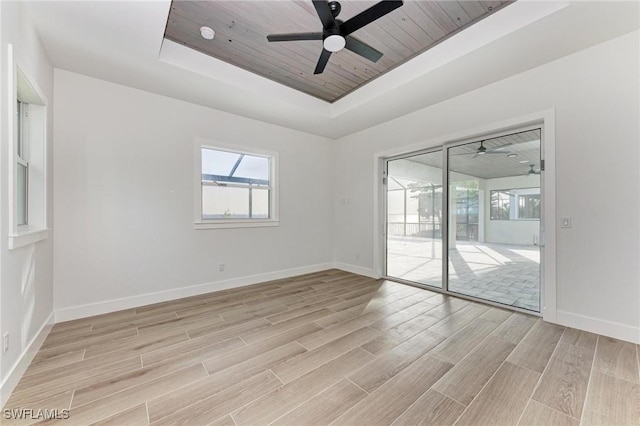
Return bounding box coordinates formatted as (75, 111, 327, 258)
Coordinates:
(490, 188, 541, 220)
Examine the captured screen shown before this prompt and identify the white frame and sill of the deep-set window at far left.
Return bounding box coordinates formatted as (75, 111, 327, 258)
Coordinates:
(6, 44, 49, 250)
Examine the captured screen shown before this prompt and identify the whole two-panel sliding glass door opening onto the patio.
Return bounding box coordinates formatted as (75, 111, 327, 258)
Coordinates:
(385, 128, 543, 312)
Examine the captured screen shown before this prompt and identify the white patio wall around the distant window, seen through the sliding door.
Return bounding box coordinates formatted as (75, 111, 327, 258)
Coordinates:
(483, 175, 540, 245)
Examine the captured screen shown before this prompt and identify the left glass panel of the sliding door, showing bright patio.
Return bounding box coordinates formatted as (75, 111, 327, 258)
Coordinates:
(386, 150, 443, 288)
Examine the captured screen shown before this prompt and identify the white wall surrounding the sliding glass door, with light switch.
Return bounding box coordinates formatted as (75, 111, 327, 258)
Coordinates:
(335, 31, 640, 342)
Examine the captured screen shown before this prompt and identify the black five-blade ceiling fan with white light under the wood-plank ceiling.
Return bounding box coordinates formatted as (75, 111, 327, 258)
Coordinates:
(267, 0, 403, 74)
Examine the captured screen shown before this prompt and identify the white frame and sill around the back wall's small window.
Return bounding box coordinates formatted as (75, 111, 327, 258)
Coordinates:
(193, 139, 280, 229)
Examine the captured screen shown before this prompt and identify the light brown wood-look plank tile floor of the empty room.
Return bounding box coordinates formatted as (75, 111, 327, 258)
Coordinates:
(2, 270, 640, 426)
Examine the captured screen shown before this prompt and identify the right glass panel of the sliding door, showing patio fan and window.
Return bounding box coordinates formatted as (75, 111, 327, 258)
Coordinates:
(447, 129, 542, 312)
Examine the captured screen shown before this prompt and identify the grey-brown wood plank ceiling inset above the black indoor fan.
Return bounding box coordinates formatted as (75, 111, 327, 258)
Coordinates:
(165, 0, 511, 102)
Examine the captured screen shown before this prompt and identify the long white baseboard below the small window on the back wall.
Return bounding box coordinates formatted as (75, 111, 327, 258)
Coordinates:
(55, 263, 334, 322)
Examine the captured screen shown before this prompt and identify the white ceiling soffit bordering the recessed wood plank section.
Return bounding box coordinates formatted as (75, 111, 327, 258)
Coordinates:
(26, 0, 640, 138)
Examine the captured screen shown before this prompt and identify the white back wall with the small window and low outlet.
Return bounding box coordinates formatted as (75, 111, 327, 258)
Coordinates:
(54, 69, 333, 320)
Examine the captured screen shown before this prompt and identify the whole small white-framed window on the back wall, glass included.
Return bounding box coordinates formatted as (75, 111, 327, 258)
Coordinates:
(196, 145, 278, 228)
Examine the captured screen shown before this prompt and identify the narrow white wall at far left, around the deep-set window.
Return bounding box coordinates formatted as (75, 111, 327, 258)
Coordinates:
(0, 2, 53, 406)
